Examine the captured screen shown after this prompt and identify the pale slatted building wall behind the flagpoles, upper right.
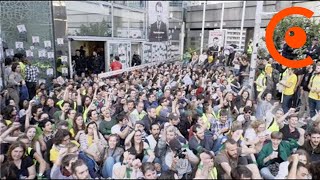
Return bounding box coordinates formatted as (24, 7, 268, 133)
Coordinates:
(186, 1, 320, 52)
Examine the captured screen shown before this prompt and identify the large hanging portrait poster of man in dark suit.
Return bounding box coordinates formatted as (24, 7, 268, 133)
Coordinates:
(148, 1, 169, 42)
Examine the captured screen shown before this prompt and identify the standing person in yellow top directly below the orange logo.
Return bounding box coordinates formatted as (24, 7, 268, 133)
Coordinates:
(280, 68, 298, 113)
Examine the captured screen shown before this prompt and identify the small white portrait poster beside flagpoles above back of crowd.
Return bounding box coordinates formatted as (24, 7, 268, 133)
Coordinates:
(208, 29, 225, 51)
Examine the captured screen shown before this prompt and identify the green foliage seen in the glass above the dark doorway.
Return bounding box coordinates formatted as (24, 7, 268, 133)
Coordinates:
(76, 19, 111, 37)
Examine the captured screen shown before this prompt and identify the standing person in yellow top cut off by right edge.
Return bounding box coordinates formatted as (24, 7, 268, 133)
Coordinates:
(308, 63, 320, 117)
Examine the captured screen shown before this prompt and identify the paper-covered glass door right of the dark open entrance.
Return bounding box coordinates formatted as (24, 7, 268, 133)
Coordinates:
(107, 41, 131, 70)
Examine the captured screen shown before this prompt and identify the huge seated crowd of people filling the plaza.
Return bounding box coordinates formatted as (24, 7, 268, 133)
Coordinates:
(0, 37, 320, 179)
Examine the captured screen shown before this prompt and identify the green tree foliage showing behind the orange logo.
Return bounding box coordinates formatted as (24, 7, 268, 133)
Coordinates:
(273, 16, 320, 52)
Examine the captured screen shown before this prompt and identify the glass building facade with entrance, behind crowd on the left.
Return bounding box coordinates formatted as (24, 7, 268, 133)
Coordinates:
(0, 1, 183, 83)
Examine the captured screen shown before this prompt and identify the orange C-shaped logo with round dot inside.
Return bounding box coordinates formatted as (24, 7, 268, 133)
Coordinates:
(266, 7, 313, 68)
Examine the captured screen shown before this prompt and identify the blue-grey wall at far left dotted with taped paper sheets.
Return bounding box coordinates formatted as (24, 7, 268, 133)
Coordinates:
(0, 1, 55, 79)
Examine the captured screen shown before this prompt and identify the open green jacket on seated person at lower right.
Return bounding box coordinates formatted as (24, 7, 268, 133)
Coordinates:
(257, 139, 299, 168)
